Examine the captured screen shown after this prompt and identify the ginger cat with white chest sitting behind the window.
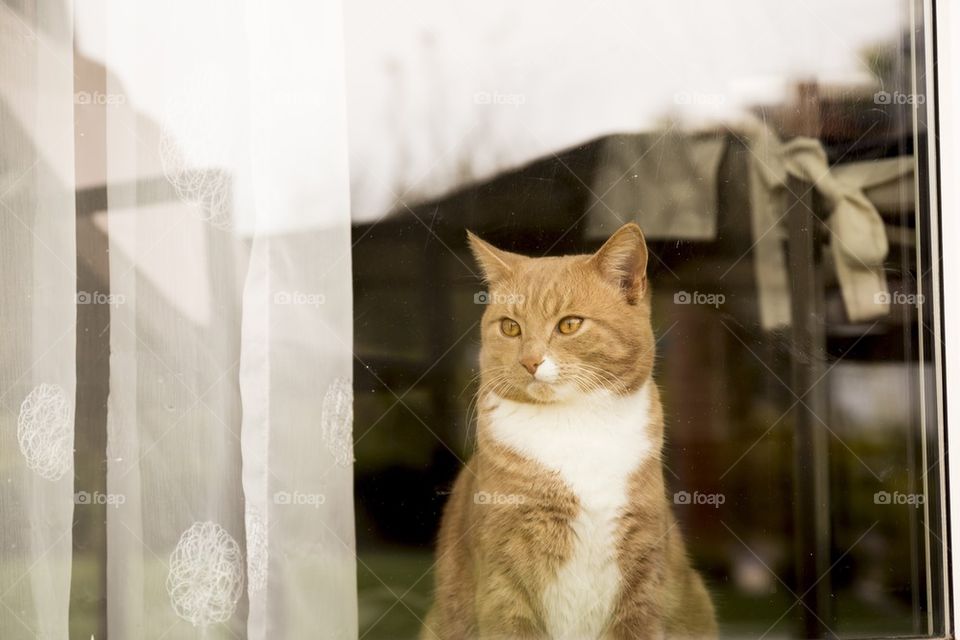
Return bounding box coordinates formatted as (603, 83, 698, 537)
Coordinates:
(421, 224, 717, 640)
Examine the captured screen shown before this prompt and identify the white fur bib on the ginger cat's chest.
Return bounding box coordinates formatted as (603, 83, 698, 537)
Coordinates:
(489, 383, 656, 640)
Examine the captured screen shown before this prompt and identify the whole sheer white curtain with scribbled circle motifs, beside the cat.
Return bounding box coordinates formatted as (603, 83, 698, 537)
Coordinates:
(0, 0, 357, 638)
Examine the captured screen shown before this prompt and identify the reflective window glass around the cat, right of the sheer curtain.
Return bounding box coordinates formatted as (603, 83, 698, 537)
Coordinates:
(346, 0, 946, 639)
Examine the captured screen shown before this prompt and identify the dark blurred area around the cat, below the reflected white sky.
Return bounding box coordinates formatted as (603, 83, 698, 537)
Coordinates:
(353, 21, 942, 638)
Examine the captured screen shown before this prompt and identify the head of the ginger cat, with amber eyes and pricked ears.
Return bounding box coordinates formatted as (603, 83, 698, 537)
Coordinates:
(468, 223, 654, 403)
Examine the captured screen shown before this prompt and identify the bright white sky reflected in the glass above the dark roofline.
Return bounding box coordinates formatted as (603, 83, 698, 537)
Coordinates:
(77, 0, 909, 225)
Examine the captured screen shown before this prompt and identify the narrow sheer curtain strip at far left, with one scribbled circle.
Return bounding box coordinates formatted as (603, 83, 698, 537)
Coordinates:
(0, 2, 78, 639)
